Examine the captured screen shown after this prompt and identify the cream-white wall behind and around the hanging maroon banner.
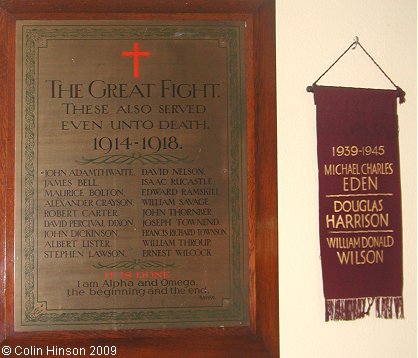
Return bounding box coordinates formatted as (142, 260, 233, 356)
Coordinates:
(276, 0, 417, 358)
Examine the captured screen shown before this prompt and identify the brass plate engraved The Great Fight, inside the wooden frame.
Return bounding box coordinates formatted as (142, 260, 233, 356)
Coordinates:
(14, 21, 249, 331)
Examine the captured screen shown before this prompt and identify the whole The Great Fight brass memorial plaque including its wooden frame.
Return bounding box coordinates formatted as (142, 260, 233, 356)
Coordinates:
(0, 1, 278, 357)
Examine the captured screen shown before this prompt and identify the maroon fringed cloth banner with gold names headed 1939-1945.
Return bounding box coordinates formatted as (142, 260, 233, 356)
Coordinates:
(314, 86, 403, 321)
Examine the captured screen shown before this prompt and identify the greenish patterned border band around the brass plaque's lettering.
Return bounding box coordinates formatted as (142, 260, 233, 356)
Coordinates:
(15, 22, 248, 330)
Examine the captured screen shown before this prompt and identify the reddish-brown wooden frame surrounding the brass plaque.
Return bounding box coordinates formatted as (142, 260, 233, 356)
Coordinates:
(0, 0, 279, 357)
